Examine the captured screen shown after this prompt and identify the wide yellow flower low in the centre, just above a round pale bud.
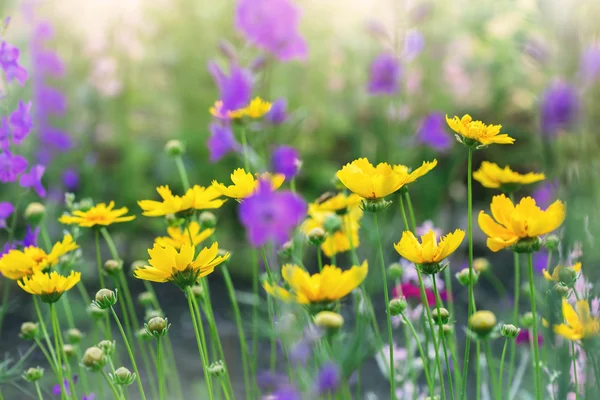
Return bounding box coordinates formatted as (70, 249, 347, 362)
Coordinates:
(263, 261, 369, 304)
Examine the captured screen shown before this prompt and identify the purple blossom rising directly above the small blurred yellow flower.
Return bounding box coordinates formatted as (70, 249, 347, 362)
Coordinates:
(208, 62, 252, 114)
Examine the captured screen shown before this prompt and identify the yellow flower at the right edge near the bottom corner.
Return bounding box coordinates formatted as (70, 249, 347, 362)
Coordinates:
(554, 299, 600, 340)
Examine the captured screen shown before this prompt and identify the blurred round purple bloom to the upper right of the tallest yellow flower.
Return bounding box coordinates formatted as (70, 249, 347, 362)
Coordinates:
(540, 81, 579, 136)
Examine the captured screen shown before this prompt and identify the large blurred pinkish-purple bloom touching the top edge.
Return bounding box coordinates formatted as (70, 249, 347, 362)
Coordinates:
(235, 0, 308, 61)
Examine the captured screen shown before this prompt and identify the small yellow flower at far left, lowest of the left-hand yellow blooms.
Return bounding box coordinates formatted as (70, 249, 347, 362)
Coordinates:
(17, 271, 81, 303)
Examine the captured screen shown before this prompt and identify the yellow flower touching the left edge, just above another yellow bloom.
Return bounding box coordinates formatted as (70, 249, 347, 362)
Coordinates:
(0, 235, 79, 280)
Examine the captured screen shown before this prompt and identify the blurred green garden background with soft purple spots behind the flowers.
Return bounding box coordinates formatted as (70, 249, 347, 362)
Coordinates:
(0, 0, 600, 393)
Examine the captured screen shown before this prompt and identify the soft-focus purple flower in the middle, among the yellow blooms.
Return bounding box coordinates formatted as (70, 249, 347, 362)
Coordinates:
(239, 180, 307, 247)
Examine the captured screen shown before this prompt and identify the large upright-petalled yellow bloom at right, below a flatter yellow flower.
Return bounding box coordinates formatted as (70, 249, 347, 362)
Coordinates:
(478, 194, 565, 252)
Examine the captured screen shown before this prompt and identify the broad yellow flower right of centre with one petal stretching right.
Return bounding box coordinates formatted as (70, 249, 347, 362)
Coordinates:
(336, 158, 437, 200)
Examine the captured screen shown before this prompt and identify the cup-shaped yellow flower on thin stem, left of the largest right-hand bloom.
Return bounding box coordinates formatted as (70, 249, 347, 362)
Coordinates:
(394, 229, 465, 273)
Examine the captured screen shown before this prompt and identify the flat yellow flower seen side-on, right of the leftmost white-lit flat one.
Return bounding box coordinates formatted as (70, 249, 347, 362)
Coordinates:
(138, 185, 225, 217)
